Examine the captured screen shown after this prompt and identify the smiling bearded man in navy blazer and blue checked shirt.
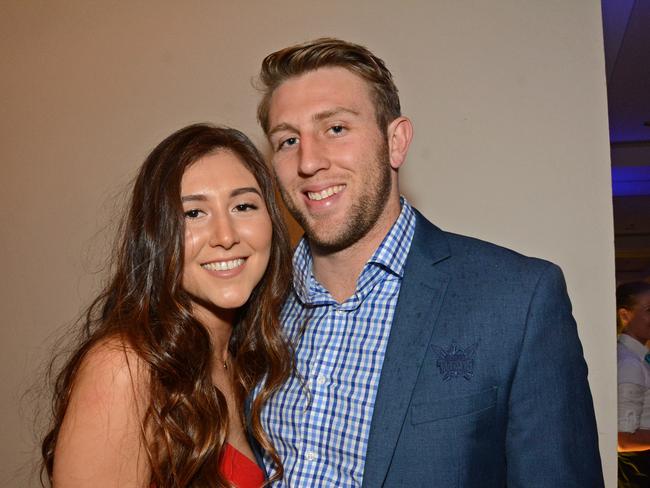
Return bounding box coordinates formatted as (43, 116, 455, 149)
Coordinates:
(258, 39, 603, 488)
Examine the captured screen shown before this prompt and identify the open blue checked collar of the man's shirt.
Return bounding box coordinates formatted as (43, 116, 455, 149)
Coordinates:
(293, 196, 415, 303)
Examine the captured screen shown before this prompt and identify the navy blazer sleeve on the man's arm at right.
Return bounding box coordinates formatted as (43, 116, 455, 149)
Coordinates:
(506, 263, 604, 488)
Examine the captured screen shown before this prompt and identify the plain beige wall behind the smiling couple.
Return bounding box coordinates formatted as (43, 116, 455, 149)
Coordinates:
(0, 0, 616, 487)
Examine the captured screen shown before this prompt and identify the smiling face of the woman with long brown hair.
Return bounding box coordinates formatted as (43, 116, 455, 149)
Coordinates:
(181, 150, 273, 318)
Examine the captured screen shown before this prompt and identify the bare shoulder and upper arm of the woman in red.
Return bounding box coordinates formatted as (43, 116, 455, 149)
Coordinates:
(54, 339, 149, 487)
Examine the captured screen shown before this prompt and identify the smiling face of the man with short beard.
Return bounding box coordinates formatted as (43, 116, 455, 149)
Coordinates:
(269, 67, 393, 252)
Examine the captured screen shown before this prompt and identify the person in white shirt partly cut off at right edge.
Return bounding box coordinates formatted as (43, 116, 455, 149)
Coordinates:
(616, 281, 650, 486)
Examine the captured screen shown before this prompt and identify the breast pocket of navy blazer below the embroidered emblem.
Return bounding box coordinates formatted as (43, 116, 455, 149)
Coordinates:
(411, 386, 498, 425)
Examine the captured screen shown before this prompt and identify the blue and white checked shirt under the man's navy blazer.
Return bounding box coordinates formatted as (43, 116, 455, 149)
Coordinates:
(262, 199, 415, 488)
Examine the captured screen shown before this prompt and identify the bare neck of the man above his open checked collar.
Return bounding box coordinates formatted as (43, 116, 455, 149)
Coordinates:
(311, 196, 401, 303)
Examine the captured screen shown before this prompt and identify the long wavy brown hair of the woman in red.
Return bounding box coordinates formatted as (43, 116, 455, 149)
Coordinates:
(41, 124, 293, 488)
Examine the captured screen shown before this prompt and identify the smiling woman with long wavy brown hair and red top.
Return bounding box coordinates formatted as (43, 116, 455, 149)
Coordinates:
(42, 124, 292, 488)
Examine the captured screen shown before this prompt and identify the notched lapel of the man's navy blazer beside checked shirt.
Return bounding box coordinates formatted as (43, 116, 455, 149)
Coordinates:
(363, 211, 450, 488)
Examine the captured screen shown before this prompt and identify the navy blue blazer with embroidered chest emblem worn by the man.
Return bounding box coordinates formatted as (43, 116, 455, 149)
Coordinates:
(363, 213, 604, 488)
